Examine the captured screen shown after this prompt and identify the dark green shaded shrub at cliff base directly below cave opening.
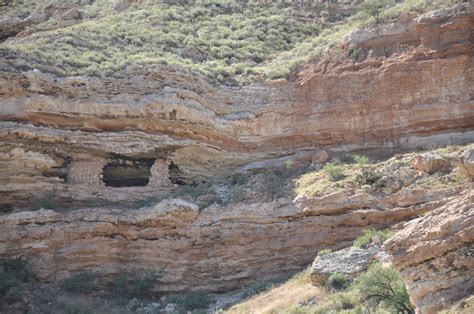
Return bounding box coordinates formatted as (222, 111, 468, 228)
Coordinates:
(112, 271, 161, 298)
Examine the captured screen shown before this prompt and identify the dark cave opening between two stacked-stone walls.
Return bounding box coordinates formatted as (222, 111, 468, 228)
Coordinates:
(102, 158, 155, 187)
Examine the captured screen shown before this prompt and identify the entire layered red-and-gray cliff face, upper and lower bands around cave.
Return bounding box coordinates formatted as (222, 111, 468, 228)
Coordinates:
(0, 4, 474, 304)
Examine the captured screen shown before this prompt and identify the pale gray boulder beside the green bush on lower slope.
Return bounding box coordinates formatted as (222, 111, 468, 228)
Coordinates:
(311, 246, 380, 286)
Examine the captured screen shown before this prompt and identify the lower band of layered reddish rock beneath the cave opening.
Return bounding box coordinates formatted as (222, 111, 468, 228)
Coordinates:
(0, 184, 456, 291)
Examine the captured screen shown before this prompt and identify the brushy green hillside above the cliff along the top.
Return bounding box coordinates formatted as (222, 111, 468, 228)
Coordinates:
(0, 0, 460, 85)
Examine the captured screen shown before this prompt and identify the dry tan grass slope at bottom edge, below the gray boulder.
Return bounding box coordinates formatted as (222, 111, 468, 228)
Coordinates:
(226, 270, 326, 314)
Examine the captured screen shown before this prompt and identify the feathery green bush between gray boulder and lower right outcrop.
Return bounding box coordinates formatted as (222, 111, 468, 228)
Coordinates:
(355, 263, 415, 314)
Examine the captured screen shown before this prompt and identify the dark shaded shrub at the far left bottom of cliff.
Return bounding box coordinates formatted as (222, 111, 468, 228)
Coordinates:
(0, 258, 34, 303)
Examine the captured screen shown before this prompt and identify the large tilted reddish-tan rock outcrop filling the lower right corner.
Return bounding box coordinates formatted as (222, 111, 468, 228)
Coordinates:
(384, 186, 474, 313)
